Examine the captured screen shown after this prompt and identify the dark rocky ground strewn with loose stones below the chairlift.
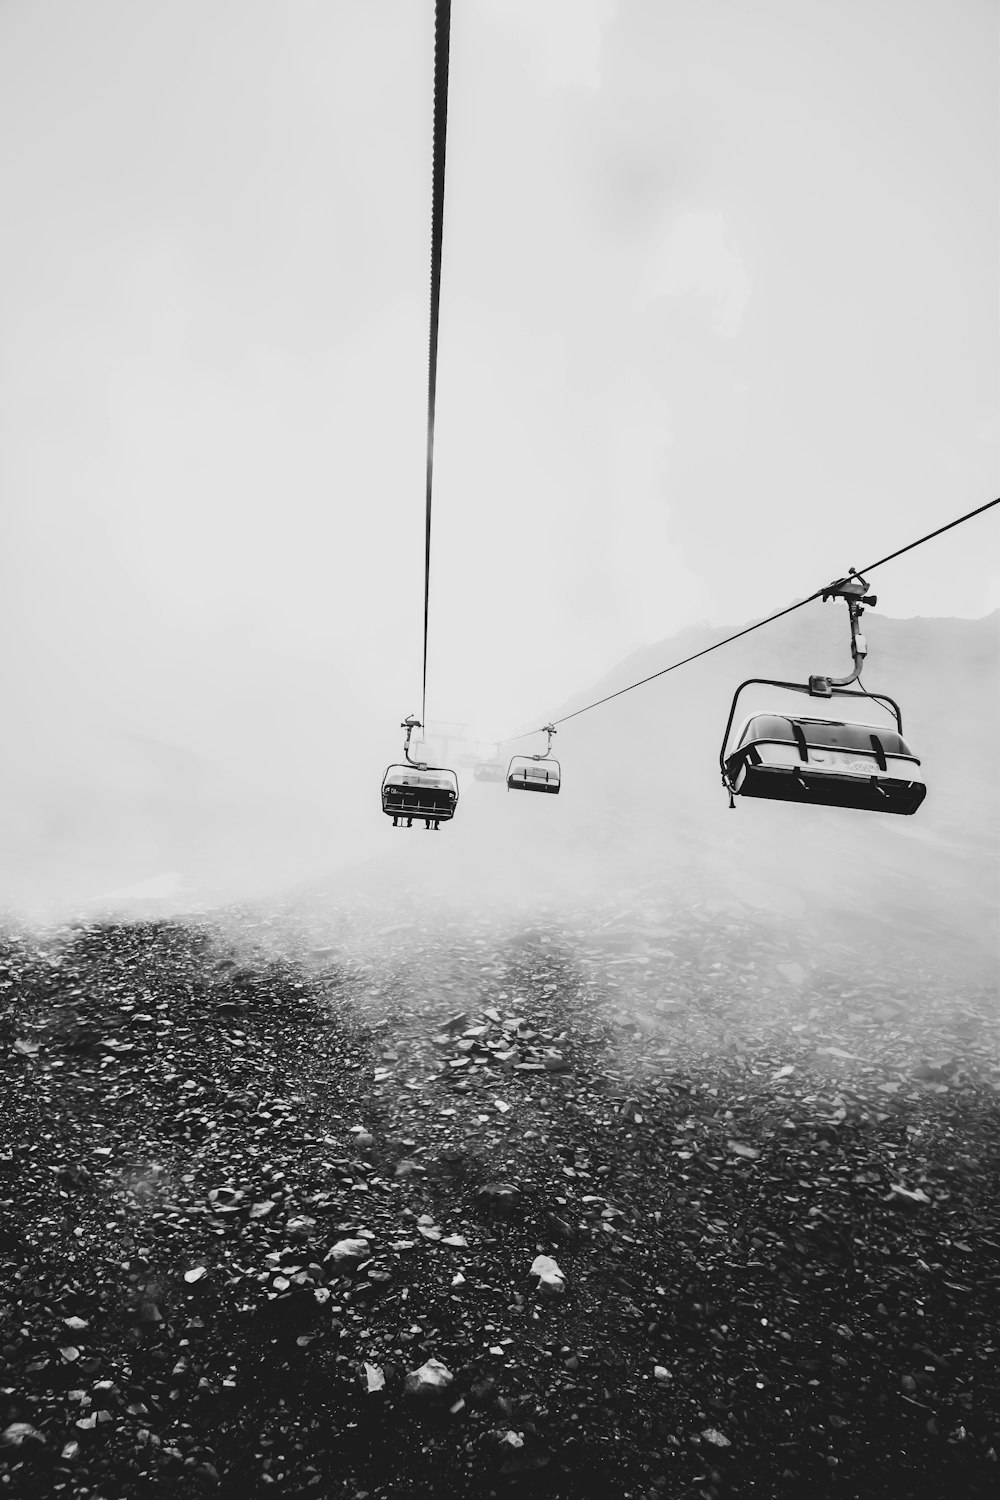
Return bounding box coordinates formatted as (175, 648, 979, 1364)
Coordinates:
(0, 888, 1000, 1500)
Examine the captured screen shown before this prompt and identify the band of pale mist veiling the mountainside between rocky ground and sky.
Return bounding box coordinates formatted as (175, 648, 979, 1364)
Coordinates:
(0, 605, 1000, 974)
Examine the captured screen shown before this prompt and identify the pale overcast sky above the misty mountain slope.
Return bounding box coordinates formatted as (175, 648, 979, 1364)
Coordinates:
(0, 0, 1000, 759)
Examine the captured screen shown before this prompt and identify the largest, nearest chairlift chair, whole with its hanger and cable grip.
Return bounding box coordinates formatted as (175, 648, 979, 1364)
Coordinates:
(720, 570, 927, 815)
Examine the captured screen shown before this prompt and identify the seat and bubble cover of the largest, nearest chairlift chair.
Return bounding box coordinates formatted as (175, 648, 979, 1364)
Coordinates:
(724, 713, 927, 815)
